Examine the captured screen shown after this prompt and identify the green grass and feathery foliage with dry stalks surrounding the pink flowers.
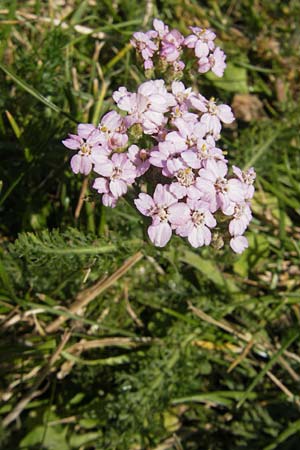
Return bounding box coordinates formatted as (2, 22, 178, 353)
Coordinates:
(0, 0, 300, 450)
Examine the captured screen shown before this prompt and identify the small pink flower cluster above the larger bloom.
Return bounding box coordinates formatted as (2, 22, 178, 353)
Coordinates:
(130, 19, 226, 77)
